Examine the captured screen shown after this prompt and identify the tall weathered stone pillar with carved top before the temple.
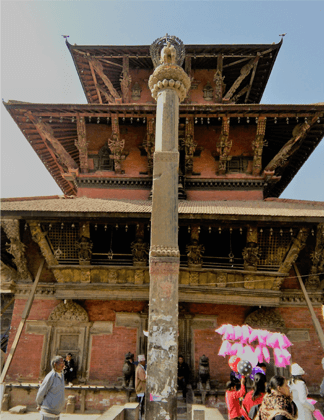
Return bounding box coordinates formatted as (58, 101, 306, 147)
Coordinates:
(145, 36, 190, 420)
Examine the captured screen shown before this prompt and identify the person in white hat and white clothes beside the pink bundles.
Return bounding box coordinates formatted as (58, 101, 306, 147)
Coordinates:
(289, 363, 315, 420)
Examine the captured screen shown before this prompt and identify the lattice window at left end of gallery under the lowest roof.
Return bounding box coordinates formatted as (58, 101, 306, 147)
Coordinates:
(47, 223, 80, 263)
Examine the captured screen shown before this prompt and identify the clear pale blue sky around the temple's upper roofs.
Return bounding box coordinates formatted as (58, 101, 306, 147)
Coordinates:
(0, 0, 324, 201)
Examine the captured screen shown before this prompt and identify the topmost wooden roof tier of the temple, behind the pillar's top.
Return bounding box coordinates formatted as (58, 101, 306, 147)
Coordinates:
(66, 41, 282, 104)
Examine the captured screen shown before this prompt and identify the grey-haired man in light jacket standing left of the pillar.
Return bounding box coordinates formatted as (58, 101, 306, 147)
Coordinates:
(36, 356, 65, 420)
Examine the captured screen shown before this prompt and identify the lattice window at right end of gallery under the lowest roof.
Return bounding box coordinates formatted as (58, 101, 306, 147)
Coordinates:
(258, 229, 291, 266)
